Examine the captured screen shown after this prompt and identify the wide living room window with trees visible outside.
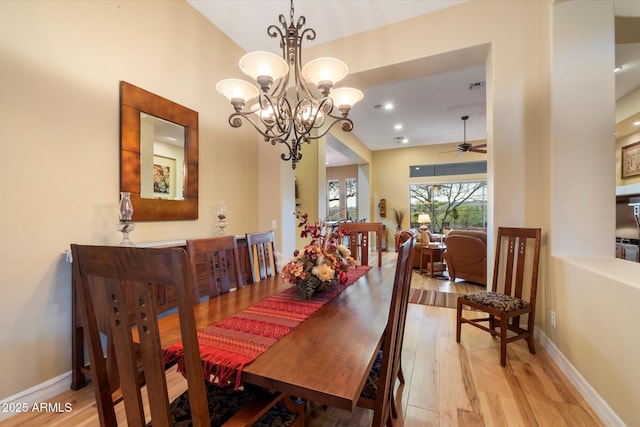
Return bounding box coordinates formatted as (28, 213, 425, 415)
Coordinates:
(410, 181, 487, 232)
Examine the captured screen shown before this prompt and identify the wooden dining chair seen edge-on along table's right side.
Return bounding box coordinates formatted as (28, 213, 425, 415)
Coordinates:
(357, 229, 416, 427)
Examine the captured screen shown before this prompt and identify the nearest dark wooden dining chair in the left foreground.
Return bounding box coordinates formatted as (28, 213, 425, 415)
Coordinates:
(71, 245, 304, 427)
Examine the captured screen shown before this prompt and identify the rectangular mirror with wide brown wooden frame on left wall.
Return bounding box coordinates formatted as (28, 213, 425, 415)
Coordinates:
(120, 81, 198, 221)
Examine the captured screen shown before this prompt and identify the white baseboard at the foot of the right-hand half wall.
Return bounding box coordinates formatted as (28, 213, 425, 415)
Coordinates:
(535, 327, 627, 427)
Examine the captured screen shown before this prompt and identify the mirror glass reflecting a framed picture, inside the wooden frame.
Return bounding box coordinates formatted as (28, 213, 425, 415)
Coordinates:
(140, 113, 185, 200)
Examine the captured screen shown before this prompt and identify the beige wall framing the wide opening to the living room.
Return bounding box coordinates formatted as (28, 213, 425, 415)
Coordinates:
(307, 1, 551, 268)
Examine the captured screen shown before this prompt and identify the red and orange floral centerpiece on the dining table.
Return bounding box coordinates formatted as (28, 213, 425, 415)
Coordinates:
(280, 212, 356, 299)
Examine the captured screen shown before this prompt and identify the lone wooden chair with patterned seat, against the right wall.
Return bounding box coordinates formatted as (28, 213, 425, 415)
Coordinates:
(456, 227, 541, 366)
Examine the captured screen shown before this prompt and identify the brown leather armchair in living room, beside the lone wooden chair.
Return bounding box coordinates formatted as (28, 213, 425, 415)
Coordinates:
(442, 229, 487, 286)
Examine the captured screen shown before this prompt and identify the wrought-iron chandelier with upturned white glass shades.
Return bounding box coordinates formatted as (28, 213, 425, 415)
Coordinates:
(216, 0, 364, 169)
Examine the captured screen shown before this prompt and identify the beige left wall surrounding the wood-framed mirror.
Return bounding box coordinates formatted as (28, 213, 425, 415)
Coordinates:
(0, 1, 260, 400)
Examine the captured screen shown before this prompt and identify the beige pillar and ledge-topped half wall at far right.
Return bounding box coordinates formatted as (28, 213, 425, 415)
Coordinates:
(540, 1, 640, 426)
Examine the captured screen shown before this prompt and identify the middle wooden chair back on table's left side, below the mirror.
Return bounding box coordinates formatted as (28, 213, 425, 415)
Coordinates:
(187, 236, 244, 298)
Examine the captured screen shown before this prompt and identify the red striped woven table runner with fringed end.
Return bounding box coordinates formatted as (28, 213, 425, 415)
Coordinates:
(164, 265, 371, 389)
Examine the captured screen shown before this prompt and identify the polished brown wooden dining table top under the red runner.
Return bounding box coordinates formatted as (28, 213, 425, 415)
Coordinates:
(159, 268, 395, 411)
